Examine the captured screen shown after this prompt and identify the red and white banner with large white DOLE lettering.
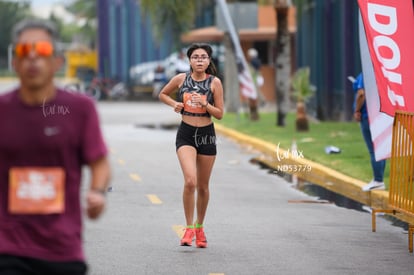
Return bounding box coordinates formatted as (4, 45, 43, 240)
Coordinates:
(358, 0, 414, 160)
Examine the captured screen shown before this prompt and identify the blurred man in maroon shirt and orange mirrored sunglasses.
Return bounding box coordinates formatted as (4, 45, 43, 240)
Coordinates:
(0, 20, 110, 275)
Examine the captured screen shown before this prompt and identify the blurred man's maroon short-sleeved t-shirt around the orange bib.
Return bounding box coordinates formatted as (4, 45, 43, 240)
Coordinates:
(0, 90, 107, 261)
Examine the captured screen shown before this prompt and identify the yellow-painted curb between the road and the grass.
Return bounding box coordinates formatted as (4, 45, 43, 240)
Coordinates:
(215, 122, 414, 226)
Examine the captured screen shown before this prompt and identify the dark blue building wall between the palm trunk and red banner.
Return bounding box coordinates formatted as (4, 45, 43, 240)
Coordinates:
(295, 0, 361, 120)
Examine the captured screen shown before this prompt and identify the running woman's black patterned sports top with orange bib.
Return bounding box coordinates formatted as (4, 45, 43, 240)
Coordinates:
(177, 72, 214, 117)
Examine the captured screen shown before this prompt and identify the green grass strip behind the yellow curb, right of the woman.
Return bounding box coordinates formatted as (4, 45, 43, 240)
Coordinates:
(216, 112, 389, 188)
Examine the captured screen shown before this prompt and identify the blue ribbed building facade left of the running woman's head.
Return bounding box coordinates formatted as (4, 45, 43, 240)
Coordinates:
(97, 0, 173, 81)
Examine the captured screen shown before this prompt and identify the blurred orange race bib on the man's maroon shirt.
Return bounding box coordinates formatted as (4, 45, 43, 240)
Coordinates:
(9, 167, 65, 214)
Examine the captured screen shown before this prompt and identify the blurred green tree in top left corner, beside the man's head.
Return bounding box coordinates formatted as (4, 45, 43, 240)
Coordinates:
(0, 1, 31, 68)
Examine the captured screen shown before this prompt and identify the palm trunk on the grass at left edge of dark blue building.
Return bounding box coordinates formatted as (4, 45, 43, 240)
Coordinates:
(274, 0, 292, 127)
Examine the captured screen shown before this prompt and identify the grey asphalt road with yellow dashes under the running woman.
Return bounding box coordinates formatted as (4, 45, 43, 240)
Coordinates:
(0, 83, 414, 275)
